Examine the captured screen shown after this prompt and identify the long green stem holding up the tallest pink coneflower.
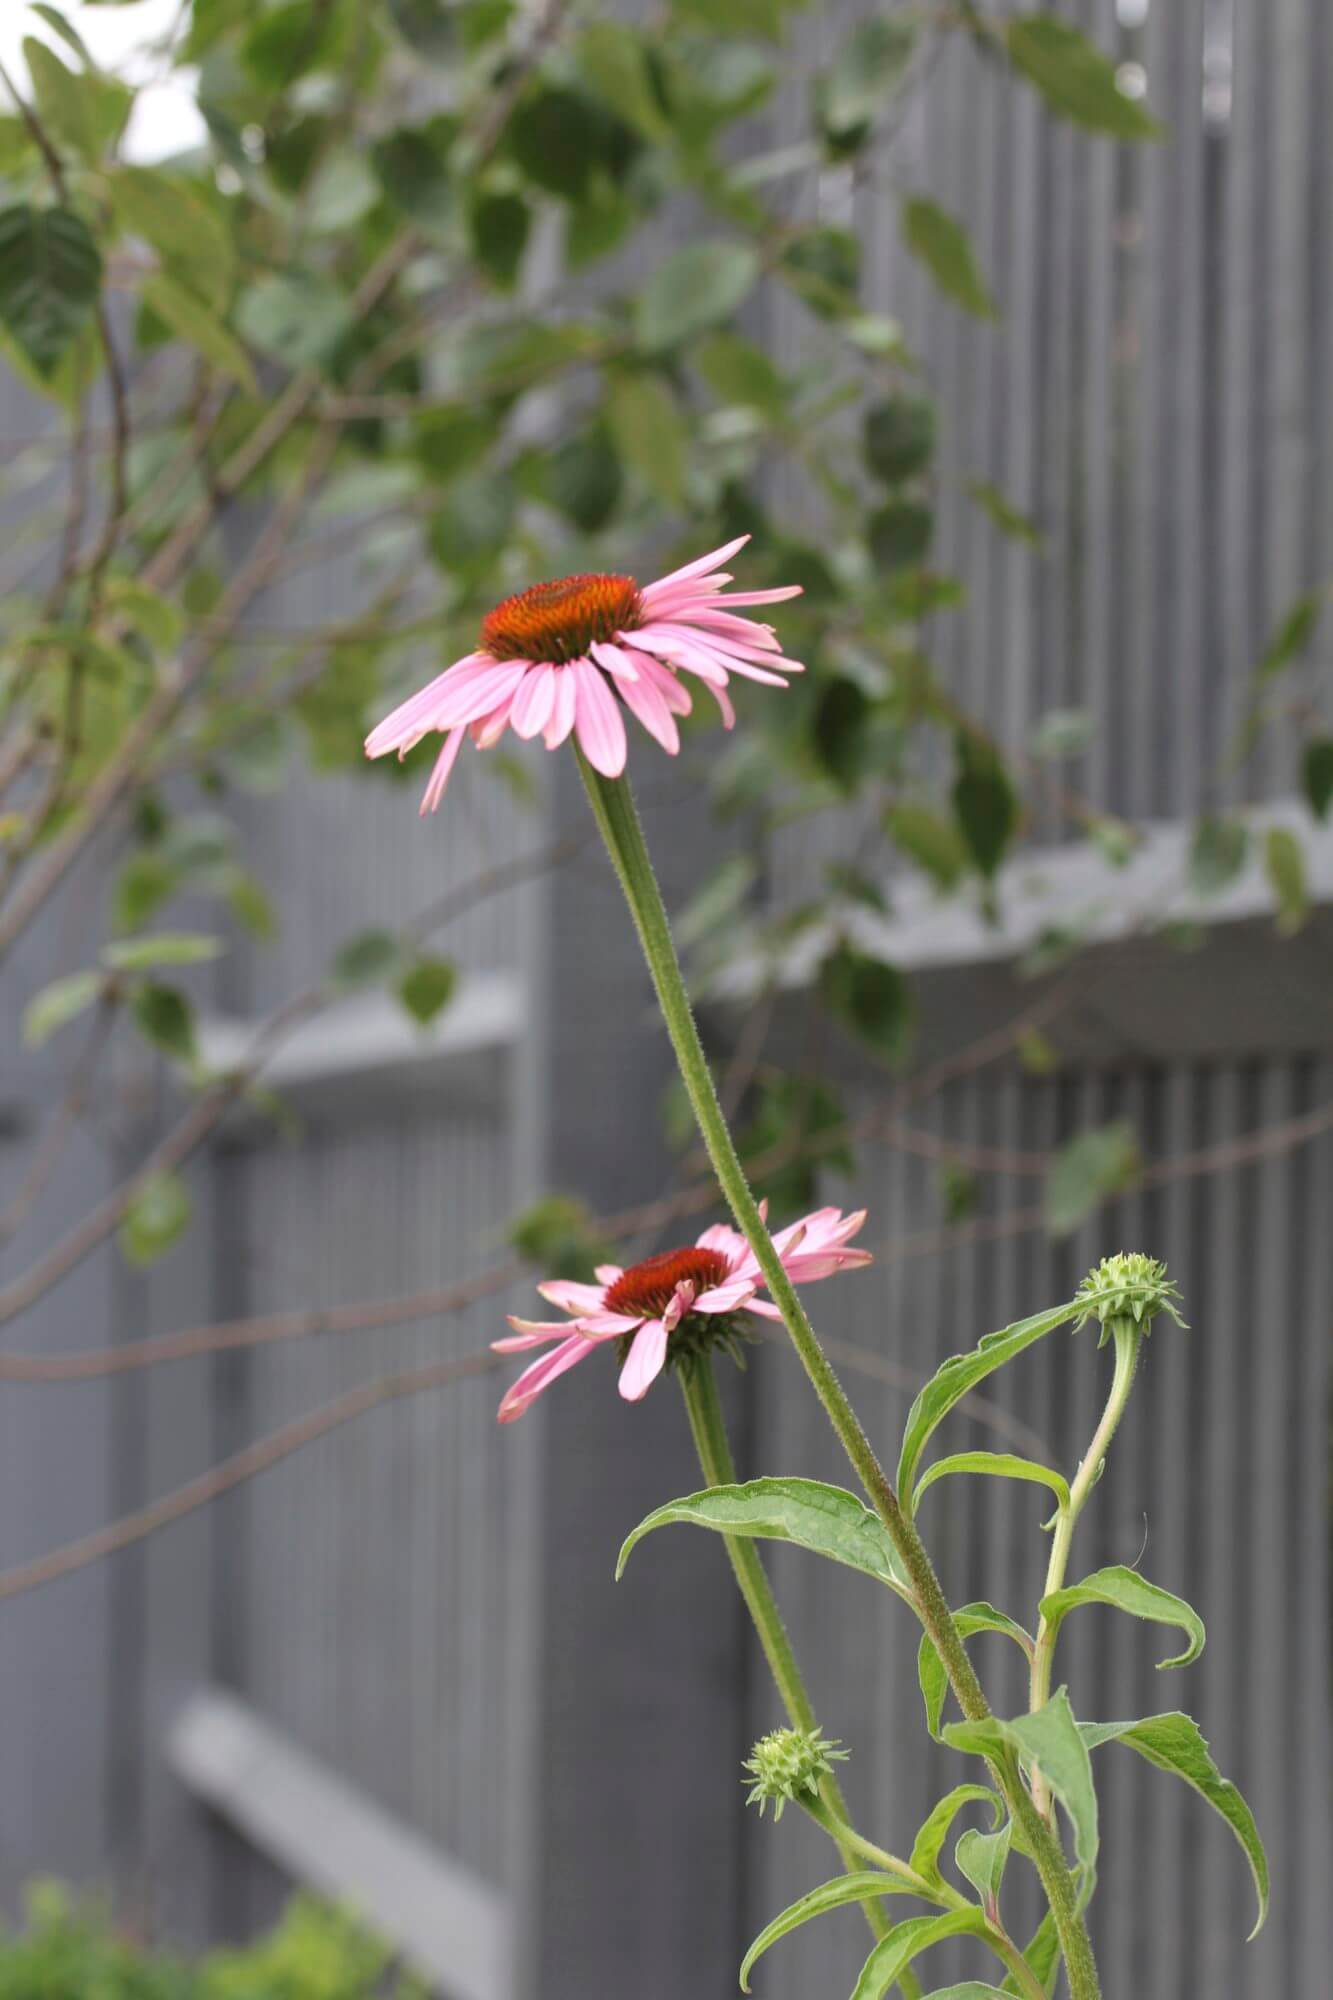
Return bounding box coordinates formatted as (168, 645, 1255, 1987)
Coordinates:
(578, 750, 1101, 2000)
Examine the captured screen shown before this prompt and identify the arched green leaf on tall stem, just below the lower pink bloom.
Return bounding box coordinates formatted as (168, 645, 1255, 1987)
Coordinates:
(616, 1478, 907, 1596)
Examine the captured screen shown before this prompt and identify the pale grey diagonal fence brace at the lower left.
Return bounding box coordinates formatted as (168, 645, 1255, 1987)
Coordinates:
(166, 1688, 510, 2000)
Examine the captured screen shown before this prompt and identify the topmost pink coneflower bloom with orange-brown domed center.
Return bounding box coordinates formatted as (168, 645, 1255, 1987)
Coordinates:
(366, 534, 803, 812)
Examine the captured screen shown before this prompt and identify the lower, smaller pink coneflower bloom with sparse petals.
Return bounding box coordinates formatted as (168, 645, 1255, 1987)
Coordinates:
(490, 1208, 871, 1424)
